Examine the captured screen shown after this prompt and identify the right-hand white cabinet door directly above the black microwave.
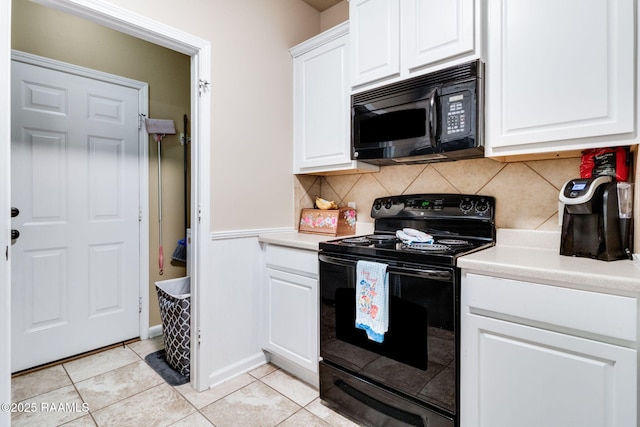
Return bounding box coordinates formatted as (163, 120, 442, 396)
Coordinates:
(401, 0, 475, 71)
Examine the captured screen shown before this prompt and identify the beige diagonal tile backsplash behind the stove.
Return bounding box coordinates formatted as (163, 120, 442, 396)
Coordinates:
(295, 158, 580, 230)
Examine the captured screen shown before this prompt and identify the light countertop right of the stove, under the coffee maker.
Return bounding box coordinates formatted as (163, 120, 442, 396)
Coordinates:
(458, 230, 640, 296)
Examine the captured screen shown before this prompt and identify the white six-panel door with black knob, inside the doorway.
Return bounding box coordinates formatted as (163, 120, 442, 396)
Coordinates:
(11, 61, 140, 372)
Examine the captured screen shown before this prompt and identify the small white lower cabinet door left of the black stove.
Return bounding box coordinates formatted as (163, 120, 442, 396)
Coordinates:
(265, 268, 319, 373)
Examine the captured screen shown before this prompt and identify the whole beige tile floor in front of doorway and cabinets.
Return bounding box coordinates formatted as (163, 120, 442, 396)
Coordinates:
(11, 337, 356, 427)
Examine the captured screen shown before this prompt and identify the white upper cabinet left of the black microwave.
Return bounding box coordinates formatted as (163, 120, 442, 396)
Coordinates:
(291, 23, 379, 174)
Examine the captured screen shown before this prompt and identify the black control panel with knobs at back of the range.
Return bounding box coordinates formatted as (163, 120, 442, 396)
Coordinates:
(371, 194, 495, 218)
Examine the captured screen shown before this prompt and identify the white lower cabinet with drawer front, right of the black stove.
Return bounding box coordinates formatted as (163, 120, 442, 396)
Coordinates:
(460, 271, 638, 427)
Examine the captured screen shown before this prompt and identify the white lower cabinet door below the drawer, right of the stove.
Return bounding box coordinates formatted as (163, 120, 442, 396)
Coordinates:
(460, 313, 637, 427)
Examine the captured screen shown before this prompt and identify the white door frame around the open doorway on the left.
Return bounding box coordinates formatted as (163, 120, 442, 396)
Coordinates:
(0, 0, 212, 394)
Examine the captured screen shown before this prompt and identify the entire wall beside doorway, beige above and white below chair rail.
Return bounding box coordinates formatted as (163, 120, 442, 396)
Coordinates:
(90, 0, 320, 385)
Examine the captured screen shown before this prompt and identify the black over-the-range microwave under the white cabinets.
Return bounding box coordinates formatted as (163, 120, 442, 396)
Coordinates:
(351, 60, 484, 165)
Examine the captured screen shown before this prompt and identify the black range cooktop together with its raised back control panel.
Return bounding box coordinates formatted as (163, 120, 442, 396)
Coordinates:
(320, 194, 495, 266)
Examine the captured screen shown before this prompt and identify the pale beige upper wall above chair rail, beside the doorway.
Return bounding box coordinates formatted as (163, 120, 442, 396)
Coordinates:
(102, 0, 320, 231)
